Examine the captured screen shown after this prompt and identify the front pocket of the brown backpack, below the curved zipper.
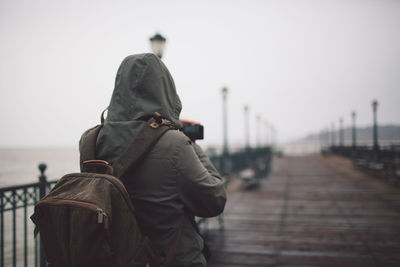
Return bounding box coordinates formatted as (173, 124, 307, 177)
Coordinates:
(34, 199, 115, 267)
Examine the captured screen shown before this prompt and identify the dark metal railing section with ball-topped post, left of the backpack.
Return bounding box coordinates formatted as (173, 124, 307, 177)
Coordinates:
(0, 164, 57, 267)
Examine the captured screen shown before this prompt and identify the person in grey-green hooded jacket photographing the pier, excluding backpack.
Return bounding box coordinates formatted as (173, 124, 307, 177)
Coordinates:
(83, 54, 226, 266)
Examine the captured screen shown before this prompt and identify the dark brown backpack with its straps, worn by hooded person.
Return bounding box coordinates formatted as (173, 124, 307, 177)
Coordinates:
(31, 112, 183, 267)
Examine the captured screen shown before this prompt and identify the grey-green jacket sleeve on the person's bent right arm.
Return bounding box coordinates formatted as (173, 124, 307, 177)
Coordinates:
(175, 141, 226, 217)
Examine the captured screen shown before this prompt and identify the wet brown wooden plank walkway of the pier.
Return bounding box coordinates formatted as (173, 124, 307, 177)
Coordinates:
(208, 155, 400, 267)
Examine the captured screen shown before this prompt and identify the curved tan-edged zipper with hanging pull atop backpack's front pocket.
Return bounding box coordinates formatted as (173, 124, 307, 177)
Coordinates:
(36, 198, 108, 229)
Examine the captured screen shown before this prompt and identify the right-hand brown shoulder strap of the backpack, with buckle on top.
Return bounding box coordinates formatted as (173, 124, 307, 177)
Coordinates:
(113, 113, 176, 181)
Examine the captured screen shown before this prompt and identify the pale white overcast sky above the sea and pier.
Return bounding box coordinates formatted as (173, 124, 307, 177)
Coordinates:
(0, 0, 400, 147)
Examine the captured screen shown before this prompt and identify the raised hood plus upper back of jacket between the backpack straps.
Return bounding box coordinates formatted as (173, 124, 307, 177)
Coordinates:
(96, 54, 182, 163)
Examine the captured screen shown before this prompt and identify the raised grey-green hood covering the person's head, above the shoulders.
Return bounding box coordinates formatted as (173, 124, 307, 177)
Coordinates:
(107, 54, 182, 127)
